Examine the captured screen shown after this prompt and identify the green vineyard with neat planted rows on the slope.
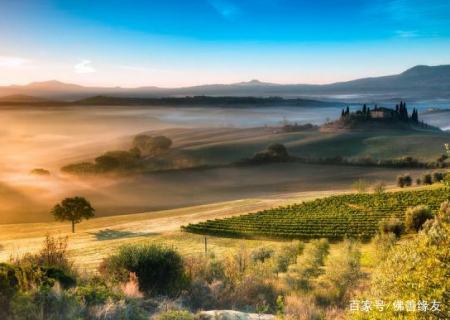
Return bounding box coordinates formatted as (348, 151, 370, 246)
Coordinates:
(182, 188, 450, 240)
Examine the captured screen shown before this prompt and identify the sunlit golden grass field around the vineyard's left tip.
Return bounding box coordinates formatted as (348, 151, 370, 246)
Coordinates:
(0, 191, 344, 270)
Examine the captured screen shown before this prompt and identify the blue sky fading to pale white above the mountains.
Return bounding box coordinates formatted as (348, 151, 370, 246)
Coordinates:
(0, 0, 450, 87)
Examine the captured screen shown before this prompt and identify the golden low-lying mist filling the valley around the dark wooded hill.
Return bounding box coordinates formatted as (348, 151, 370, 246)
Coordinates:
(0, 107, 446, 223)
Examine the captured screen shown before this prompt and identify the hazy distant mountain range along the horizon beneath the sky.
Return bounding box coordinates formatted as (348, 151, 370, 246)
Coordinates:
(0, 65, 450, 102)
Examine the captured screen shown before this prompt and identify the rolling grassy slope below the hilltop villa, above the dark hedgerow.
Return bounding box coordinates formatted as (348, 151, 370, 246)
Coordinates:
(159, 128, 450, 164)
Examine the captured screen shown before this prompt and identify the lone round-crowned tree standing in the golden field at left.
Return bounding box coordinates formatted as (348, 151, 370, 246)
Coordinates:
(52, 197, 95, 232)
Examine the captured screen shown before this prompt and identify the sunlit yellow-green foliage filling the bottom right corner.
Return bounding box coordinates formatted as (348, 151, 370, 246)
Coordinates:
(352, 201, 450, 320)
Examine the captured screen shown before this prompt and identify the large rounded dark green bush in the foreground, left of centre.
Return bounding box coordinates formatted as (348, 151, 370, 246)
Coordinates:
(100, 244, 187, 295)
